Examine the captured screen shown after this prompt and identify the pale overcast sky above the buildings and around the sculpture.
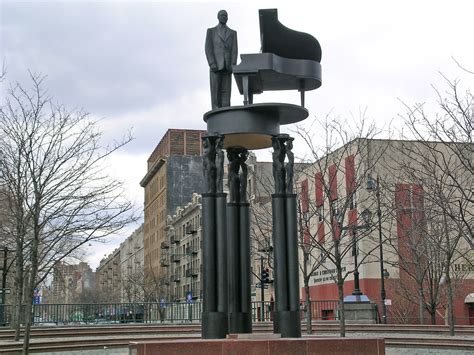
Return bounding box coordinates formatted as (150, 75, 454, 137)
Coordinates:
(0, 0, 474, 267)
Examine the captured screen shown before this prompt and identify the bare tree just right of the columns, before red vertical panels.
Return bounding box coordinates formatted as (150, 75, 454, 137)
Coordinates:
(296, 115, 383, 337)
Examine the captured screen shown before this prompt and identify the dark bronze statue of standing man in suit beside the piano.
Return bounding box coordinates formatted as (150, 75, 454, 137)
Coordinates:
(206, 10, 237, 110)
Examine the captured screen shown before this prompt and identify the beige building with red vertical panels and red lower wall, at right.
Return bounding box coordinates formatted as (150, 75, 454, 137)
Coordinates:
(299, 139, 474, 324)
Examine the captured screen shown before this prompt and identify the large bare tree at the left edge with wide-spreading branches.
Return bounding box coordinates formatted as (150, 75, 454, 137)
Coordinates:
(0, 75, 135, 354)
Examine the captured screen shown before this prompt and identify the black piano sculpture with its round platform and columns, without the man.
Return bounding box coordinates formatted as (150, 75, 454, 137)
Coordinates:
(202, 9, 321, 338)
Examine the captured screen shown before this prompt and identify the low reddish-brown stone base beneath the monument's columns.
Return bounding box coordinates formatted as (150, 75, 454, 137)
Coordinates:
(129, 335, 385, 355)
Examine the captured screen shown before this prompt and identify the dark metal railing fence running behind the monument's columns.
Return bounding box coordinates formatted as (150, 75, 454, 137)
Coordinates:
(0, 301, 338, 326)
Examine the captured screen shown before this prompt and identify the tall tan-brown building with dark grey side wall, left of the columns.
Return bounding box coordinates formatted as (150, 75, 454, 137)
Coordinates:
(140, 129, 207, 279)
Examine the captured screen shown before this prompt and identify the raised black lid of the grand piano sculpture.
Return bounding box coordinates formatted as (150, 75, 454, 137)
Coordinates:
(259, 9, 322, 63)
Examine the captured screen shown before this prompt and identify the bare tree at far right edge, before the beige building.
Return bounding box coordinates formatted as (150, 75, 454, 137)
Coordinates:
(396, 71, 474, 335)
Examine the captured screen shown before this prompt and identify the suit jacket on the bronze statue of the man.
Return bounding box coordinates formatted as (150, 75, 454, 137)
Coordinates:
(206, 25, 238, 72)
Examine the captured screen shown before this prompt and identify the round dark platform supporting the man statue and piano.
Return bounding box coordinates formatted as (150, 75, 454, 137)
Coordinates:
(204, 103, 308, 149)
